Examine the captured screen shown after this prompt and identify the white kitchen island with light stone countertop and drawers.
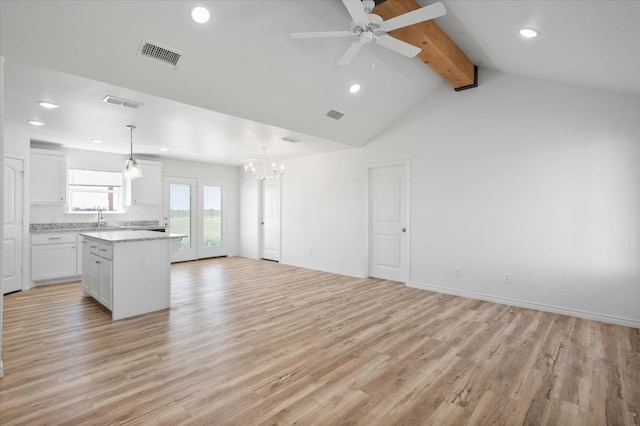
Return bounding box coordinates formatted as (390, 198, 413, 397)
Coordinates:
(80, 231, 184, 320)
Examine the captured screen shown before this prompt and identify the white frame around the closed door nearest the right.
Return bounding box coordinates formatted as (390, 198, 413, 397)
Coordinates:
(362, 160, 411, 285)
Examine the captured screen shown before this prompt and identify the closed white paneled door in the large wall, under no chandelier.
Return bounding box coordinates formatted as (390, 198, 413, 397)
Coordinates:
(368, 164, 409, 282)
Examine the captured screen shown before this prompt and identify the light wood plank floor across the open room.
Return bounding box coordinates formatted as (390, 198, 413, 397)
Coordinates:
(0, 258, 640, 426)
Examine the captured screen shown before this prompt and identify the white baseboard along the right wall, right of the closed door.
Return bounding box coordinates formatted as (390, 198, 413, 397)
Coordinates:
(407, 282, 640, 328)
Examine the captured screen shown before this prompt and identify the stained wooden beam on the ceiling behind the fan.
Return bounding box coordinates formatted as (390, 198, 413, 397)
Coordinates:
(371, 0, 478, 90)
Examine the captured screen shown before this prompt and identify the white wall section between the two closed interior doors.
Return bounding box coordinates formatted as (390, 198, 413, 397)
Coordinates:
(281, 149, 365, 277)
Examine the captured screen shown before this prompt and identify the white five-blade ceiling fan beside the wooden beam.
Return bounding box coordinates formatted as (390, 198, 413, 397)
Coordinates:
(291, 0, 447, 65)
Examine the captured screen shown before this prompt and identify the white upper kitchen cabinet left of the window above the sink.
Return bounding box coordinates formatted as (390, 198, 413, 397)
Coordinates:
(29, 149, 67, 204)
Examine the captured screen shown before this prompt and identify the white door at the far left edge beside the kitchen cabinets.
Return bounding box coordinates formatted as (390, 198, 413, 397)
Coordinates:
(2, 157, 24, 294)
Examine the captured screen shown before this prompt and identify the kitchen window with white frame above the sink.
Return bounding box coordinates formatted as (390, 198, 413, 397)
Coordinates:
(69, 169, 122, 213)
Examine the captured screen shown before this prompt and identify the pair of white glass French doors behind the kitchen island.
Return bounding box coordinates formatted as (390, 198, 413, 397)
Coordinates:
(164, 176, 227, 262)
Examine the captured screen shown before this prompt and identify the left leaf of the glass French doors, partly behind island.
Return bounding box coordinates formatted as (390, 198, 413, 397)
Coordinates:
(164, 176, 198, 262)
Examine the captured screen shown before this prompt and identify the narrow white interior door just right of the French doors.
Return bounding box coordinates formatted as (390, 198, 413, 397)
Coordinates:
(261, 180, 281, 261)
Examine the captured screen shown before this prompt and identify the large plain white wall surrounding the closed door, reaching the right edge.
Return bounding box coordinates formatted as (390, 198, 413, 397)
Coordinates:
(274, 70, 640, 326)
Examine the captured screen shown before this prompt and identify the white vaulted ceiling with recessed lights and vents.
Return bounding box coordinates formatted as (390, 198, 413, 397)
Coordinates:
(0, 0, 640, 164)
